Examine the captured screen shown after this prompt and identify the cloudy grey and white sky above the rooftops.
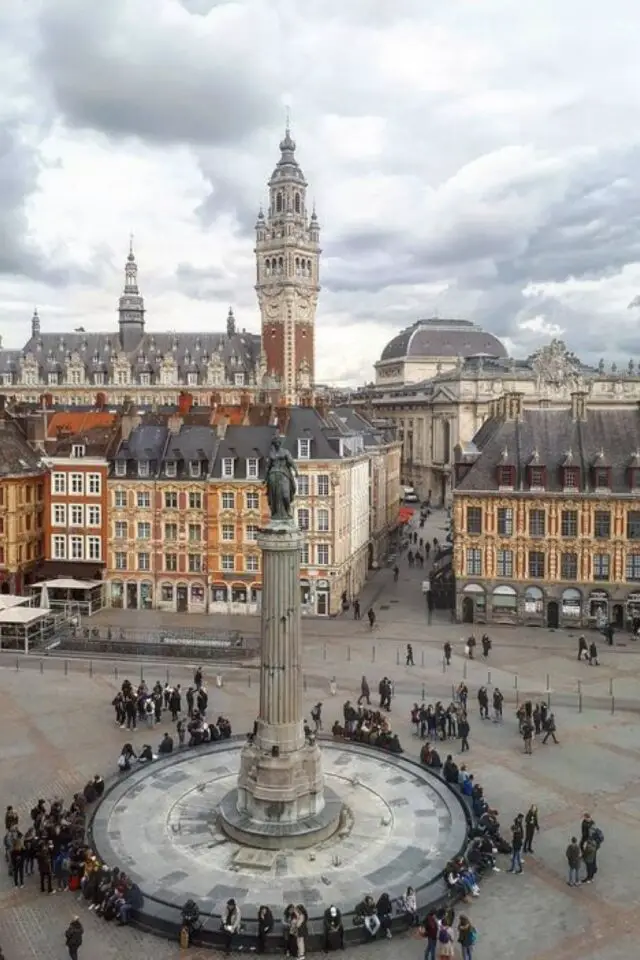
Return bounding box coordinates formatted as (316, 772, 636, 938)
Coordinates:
(0, 0, 640, 383)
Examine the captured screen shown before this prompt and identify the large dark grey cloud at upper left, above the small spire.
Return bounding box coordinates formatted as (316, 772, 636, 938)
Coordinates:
(39, 0, 277, 144)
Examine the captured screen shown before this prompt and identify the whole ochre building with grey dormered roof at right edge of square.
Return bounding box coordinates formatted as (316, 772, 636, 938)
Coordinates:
(453, 389, 640, 628)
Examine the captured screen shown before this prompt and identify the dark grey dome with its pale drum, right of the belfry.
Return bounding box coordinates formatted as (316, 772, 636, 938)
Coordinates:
(375, 317, 507, 387)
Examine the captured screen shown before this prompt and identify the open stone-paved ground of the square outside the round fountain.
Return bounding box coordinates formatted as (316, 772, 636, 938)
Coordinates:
(0, 516, 640, 960)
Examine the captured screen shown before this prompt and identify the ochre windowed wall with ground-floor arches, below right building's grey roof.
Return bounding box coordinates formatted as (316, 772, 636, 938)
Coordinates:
(453, 492, 640, 627)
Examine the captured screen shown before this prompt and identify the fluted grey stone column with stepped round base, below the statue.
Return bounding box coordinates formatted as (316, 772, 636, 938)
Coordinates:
(221, 521, 340, 848)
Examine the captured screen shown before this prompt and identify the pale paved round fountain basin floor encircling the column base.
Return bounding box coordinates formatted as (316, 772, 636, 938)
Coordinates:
(92, 741, 468, 925)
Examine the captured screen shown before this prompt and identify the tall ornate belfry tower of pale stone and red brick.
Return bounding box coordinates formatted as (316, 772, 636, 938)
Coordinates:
(255, 125, 321, 404)
